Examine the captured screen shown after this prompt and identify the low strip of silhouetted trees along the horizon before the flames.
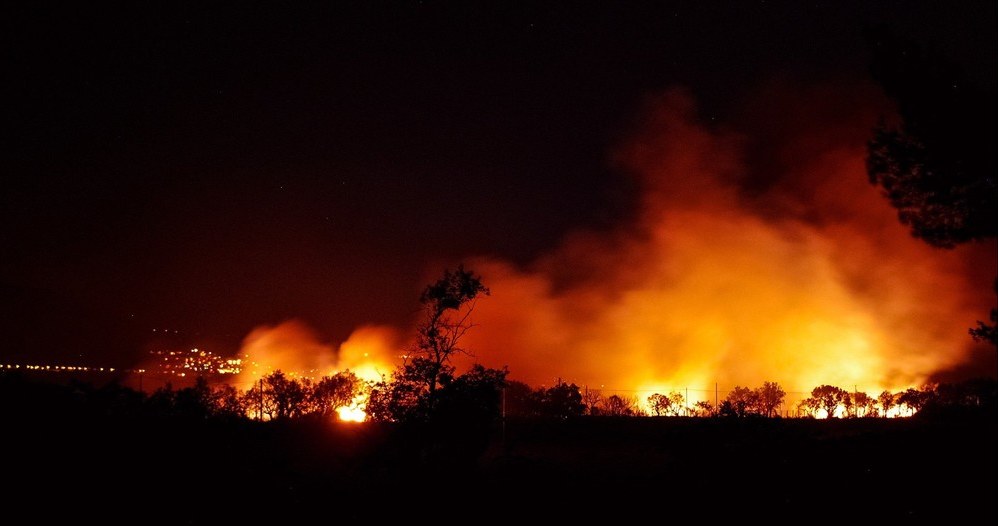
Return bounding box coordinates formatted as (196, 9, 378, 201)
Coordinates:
(0, 372, 998, 423)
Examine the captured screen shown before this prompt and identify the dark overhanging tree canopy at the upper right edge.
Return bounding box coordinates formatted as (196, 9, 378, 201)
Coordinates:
(867, 28, 998, 248)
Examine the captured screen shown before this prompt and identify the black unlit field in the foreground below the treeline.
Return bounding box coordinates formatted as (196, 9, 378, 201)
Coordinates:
(2, 408, 996, 525)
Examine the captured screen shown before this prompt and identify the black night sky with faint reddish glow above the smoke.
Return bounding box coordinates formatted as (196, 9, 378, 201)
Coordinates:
(0, 1, 995, 366)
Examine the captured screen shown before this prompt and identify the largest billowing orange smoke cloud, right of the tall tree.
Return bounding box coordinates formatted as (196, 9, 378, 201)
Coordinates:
(464, 84, 994, 399)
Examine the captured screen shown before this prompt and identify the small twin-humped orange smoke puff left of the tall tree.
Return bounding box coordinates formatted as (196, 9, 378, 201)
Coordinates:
(237, 320, 399, 384)
